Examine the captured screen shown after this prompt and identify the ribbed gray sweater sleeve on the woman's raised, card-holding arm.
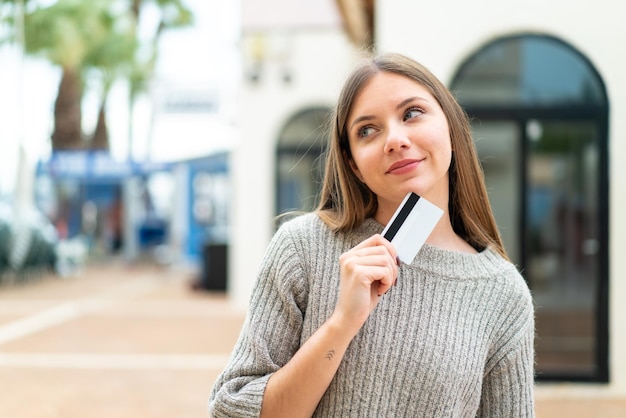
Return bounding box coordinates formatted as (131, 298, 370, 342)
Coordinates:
(209, 220, 307, 418)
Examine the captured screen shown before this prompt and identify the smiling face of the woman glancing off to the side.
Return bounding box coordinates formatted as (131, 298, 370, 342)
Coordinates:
(346, 72, 452, 222)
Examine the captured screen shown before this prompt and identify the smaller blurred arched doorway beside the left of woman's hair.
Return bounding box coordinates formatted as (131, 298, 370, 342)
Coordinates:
(275, 107, 331, 220)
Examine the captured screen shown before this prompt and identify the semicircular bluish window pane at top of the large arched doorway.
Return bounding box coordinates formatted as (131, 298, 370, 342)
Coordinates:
(454, 36, 604, 106)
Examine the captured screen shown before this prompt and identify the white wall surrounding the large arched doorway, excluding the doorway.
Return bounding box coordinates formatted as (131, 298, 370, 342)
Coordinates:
(376, 0, 626, 396)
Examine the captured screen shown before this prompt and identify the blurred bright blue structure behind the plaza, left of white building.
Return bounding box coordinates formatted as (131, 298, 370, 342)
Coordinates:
(36, 151, 230, 263)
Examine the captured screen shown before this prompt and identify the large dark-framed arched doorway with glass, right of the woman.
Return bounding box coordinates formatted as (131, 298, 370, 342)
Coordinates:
(451, 34, 608, 381)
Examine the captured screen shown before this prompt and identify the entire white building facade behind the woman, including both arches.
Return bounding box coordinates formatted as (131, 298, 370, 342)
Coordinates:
(229, 0, 626, 396)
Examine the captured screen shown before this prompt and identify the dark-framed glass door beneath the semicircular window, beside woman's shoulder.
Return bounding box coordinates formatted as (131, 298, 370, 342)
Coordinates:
(472, 119, 601, 379)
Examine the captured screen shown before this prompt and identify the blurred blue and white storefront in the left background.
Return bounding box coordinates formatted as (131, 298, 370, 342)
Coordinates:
(36, 151, 230, 268)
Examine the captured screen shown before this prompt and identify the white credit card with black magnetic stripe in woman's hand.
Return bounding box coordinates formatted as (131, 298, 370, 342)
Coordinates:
(382, 192, 443, 264)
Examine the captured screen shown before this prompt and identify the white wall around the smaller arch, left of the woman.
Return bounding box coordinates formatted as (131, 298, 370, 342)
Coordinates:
(229, 28, 354, 308)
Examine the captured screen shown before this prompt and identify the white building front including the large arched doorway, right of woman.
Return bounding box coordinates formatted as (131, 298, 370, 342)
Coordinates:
(376, 0, 626, 393)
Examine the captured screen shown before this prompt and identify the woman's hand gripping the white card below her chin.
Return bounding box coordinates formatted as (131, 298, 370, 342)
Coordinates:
(331, 234, 398, 335)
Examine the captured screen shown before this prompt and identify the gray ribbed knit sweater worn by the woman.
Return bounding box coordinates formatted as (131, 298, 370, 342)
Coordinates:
(209, 214, 534, 418)
